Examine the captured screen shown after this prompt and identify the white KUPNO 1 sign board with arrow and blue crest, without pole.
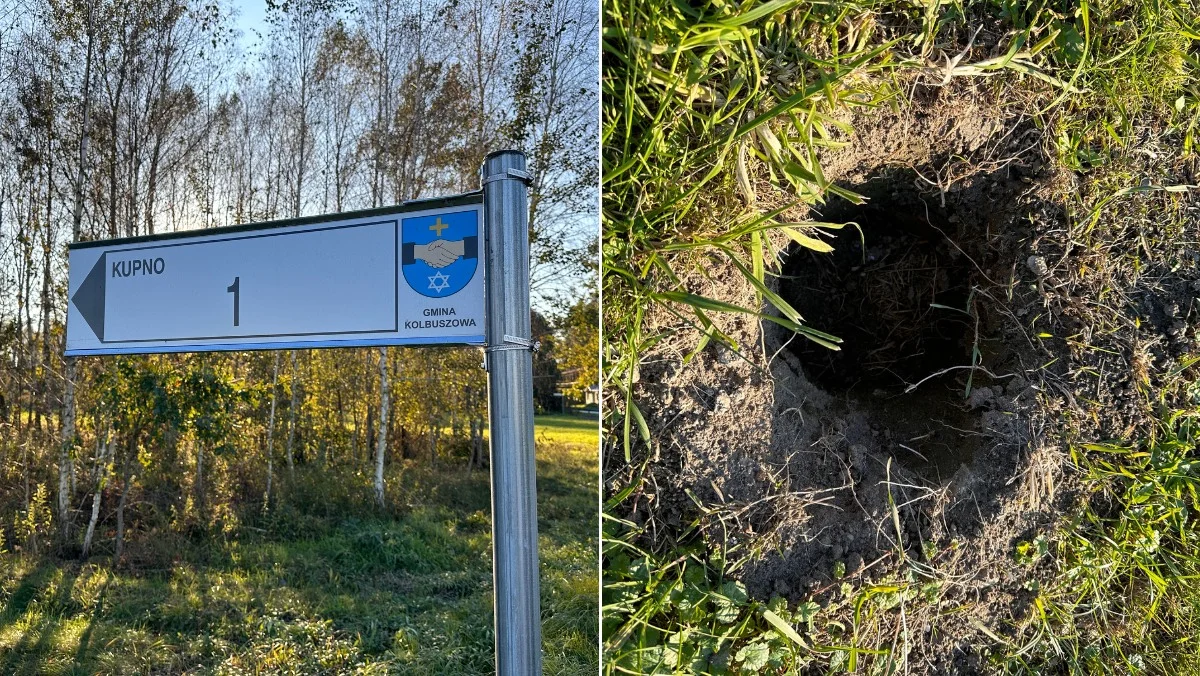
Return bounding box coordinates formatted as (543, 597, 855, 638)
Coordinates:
(66, 195, 485, 355)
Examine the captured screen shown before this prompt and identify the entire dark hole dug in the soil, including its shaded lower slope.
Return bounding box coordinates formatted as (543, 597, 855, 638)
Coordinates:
(780, 187, 986, 481)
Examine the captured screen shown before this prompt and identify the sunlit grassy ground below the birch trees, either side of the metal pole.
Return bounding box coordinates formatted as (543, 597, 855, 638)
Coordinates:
(0, 417, 599, 675)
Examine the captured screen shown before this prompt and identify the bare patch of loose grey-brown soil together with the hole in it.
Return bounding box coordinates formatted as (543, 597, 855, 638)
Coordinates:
(608, 79, 1200, 672)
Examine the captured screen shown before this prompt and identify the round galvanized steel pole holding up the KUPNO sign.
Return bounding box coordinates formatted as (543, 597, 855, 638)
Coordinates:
(482, 150, 541, 676)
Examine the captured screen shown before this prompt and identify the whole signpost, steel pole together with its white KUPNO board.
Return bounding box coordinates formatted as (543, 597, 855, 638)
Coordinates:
(66, 150, 541, 676)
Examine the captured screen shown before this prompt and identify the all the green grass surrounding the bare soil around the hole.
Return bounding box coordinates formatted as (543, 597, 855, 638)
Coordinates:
(602, 0, 1200, 674)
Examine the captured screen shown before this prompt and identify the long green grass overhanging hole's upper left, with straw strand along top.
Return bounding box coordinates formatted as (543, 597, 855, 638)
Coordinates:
(601, 0, 1076, 460)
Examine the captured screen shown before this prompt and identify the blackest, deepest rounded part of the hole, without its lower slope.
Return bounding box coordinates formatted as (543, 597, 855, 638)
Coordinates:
(782, 207, 974, 393)
